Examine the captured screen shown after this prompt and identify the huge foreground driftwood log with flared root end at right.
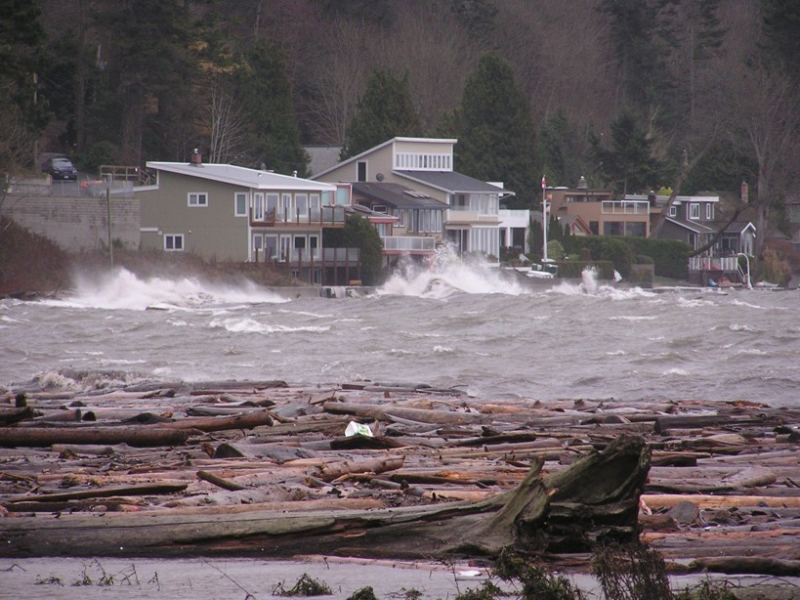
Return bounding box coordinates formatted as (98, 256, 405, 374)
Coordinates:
(0, 437, 650, 557)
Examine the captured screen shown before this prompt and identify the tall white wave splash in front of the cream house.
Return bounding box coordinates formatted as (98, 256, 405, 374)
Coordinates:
(378, 247, 527, 300)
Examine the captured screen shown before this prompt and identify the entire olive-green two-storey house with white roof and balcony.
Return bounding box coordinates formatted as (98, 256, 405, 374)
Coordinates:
(134, 153, 359, 284)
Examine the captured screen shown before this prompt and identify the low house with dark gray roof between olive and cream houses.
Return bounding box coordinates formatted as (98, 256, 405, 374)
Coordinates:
(353, 181, 447, 266)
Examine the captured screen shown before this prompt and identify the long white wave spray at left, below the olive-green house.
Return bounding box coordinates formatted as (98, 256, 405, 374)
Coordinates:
(45, 268, 289, 310)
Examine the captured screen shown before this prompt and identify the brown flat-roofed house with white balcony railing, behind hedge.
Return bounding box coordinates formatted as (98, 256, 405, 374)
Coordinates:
(545, 182, 650, 237)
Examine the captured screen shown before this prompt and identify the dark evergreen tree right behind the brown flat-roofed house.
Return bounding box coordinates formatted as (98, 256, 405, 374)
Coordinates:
(592, 111, 662, 194)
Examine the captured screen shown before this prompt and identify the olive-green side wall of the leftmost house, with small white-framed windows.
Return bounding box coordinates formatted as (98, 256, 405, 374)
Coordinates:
(137, 171, 249, 261)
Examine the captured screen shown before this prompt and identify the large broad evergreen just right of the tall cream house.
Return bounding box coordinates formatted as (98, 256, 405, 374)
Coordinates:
(456, 54, 537, 207)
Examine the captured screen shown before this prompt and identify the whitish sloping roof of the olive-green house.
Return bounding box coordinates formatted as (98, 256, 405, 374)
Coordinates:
(147, 162, 336, 192)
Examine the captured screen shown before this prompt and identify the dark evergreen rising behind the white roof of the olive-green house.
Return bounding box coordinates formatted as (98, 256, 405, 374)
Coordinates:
(238, 43, 308, 177)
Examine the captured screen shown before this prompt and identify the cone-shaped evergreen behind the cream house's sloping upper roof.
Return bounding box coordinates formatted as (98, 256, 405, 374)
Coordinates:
(340, 70, 420, 160)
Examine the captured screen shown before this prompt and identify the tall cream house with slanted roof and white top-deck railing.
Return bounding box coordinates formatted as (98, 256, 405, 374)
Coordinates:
(314, 137, 502, 260)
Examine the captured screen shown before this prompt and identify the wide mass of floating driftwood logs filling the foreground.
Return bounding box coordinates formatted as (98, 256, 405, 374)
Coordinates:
(0, 381, 800, 575)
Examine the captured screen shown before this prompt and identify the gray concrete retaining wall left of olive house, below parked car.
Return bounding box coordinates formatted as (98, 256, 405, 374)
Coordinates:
(3, 193, 140, 252)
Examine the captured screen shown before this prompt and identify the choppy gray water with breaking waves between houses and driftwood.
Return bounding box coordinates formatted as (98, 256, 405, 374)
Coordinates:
(0, 263, 800, 405)
